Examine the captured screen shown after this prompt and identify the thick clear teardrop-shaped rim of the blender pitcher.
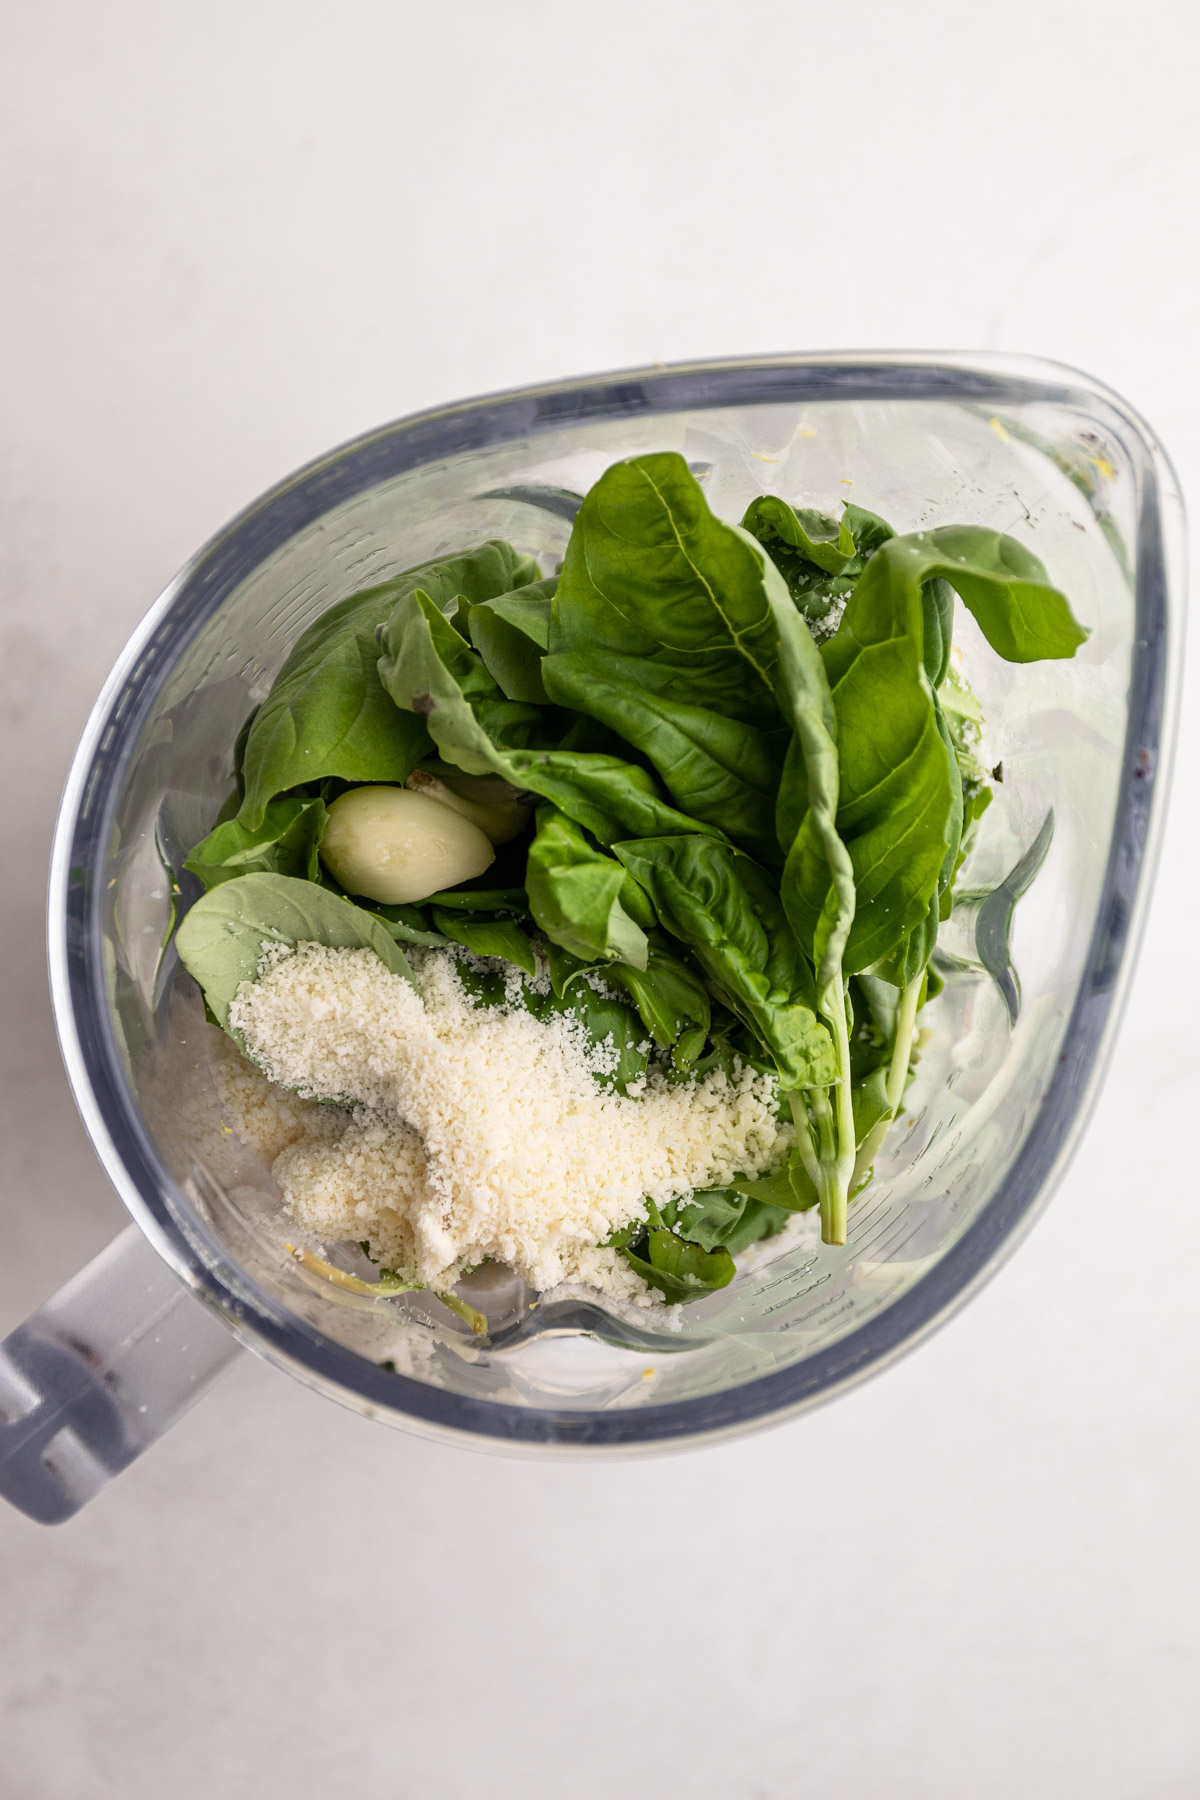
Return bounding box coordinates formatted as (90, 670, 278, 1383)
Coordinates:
(49, 351, 1182, 1453)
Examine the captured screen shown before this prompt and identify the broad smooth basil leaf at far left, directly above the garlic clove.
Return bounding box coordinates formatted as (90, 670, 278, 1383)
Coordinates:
(239, 540, 531, 830)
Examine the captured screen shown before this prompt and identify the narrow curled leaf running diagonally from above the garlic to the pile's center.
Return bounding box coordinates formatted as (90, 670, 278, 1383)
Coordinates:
(380, 590, 719, 844)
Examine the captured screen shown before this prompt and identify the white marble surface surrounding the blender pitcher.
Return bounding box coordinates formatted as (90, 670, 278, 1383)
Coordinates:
(0, 0, 1200, 1800)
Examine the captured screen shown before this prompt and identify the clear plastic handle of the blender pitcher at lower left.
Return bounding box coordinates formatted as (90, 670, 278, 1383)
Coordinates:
(0, 1226, 239, 1525)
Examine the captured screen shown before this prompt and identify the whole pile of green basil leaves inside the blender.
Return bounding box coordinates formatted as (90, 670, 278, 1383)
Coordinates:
(178, 452, 1087, 1301)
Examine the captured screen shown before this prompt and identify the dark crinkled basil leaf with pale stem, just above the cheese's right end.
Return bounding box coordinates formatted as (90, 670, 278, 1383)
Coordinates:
(612, 835, 838, 1091)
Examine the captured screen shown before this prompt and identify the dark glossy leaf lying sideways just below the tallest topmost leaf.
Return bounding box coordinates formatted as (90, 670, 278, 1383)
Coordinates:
(542, 652, 786, 862)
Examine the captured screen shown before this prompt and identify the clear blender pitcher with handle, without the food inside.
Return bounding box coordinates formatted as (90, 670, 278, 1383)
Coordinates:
(0, 353, 1182, 1523)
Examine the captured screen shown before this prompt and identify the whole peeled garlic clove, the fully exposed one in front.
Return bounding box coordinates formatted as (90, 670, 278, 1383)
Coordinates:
(320, 787, 495, 905)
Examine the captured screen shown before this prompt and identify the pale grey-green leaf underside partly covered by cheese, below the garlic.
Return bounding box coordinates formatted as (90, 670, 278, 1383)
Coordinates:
(175, 875, 412, 1030)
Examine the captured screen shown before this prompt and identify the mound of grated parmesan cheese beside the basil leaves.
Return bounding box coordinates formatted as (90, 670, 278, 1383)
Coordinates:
(223, 945, 792, 1303)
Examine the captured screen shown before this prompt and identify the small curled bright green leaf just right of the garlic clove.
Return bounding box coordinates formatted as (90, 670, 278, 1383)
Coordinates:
(525, 806, 655, 968)
